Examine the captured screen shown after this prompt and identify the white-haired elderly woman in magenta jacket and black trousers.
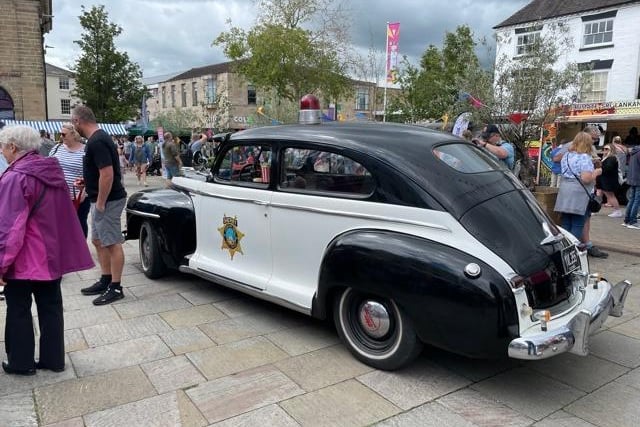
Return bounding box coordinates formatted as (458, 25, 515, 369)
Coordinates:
(0, 126, 94, 375)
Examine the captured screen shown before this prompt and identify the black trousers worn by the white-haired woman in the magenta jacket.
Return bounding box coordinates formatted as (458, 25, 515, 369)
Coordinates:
(4, 278, 64, 370)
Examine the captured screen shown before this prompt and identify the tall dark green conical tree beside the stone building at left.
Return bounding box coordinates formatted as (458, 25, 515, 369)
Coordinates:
(73, 6, 146, 122)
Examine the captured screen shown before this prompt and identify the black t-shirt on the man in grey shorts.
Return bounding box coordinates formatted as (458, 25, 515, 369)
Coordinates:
(83, 129, 127, 203)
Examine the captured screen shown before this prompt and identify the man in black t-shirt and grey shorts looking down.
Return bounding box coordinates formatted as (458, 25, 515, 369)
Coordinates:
(71, 106, 127, 305)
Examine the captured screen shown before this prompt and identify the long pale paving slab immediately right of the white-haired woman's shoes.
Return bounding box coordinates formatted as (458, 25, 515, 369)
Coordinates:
(70, 335, 173, 377)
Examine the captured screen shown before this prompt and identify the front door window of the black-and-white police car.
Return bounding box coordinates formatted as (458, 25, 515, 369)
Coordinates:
(215, 144, 271, 187)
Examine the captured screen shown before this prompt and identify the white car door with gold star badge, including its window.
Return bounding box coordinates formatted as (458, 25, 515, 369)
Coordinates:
(190, 143, 272, 290)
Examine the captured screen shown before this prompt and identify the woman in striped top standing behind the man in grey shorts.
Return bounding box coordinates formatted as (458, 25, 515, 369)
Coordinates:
(49, 123, 91, 237)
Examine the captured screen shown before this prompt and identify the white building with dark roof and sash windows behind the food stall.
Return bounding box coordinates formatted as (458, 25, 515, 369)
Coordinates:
(494, 0, 640, 140)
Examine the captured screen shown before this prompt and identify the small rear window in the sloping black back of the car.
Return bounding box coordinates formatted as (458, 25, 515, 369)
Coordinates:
(433, 144, 503, 173)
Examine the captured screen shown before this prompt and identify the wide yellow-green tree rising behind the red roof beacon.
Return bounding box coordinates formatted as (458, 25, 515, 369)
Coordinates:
(213, 0, 352, 101)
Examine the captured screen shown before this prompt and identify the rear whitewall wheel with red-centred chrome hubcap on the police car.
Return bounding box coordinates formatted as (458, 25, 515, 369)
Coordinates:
(333, 288, 422, 370)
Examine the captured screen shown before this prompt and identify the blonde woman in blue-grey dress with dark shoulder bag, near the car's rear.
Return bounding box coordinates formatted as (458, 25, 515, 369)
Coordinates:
(554, 132, 602, 249)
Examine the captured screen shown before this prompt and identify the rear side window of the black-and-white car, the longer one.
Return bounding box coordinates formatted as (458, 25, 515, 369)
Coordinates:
(280, 147, 375, 196)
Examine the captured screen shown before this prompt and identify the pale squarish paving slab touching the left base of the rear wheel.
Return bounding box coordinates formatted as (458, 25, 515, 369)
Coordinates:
(276, 345, 373, 391)
